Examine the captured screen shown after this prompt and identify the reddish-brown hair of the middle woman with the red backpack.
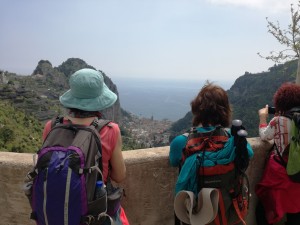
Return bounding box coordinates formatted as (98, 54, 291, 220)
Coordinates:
(191, 82, 231, 127)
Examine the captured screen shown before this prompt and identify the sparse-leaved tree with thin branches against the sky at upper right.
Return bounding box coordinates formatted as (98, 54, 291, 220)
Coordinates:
(257, 0, 300, 84)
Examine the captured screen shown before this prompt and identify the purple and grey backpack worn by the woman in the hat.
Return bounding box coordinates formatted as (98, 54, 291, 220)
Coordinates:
(28, 117, 110, 225)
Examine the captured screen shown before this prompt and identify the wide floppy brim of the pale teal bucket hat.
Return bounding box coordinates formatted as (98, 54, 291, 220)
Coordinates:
(59, 84, 118, 111)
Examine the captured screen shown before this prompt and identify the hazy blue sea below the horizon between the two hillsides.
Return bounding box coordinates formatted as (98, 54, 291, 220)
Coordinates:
(112, 78, 233, 121)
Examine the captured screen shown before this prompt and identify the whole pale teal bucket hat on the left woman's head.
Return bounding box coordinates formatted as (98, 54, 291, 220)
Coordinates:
(59, 69, 117, 111)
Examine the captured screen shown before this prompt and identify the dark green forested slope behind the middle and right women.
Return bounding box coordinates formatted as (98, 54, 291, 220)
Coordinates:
(170, 60, 297, 140)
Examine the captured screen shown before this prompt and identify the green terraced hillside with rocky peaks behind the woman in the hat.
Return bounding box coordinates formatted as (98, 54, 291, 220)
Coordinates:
(0, 58, 160, 152)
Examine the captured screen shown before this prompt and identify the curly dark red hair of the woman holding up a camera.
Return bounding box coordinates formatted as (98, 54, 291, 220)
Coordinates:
(273, 82, 300, 114)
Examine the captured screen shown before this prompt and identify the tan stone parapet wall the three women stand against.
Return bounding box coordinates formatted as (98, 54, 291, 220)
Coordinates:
(0, 138, 284, 225)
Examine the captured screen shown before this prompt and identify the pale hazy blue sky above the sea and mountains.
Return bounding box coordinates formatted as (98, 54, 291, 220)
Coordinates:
(0, 0, 298, 81)
